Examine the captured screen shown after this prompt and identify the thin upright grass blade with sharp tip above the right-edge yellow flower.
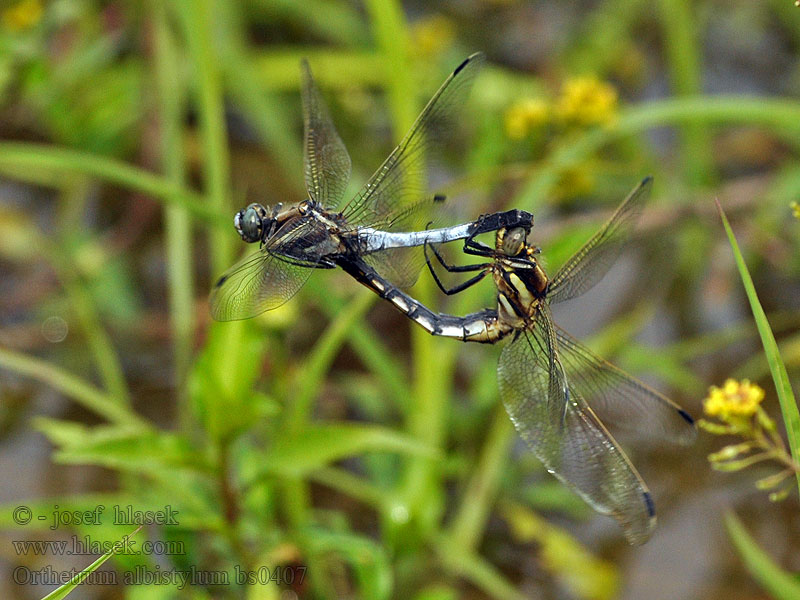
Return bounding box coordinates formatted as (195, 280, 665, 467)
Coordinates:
(717, 201, 800, 496)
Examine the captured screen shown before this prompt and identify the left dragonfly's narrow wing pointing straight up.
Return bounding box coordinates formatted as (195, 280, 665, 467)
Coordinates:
(300, 59, 352, 209)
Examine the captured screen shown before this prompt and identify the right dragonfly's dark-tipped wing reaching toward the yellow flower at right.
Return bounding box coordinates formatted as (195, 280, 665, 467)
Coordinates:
(556, 326, 697, 444)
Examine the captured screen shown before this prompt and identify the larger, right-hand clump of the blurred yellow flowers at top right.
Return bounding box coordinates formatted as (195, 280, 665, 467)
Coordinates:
(555, 77, 617, 125)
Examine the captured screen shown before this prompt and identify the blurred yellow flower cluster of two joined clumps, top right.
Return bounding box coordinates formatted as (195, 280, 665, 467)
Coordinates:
(505, 77, 618, 140)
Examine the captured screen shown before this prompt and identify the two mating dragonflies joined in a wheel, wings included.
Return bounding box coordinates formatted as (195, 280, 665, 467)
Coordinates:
(211, 54, 695, 544)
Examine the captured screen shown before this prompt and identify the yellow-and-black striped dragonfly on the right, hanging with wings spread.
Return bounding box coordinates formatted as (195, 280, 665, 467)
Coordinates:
(412, 178, 696, 544)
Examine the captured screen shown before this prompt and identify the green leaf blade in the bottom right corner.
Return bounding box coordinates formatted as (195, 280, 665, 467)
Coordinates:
(725, 511, 800, 600)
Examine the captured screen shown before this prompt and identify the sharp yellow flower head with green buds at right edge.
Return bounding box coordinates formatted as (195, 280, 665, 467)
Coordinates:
(698, 379, 800, 500)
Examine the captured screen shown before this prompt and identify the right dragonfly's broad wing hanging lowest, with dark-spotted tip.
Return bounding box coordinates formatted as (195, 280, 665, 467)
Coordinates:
(497, 307, 655, 544)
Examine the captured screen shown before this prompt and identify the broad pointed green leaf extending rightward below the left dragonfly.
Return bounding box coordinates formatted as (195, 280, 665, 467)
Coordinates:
(245, 423, 438, 480)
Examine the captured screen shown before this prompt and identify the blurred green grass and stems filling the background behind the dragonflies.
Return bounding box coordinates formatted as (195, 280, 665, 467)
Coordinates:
(0, 0, 800, 600)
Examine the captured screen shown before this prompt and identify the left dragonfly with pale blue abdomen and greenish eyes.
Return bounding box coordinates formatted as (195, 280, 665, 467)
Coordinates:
(210, 53, 533, 321)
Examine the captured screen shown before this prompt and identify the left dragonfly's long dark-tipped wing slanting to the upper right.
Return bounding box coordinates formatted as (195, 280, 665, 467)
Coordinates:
(343, 53, 485, 231)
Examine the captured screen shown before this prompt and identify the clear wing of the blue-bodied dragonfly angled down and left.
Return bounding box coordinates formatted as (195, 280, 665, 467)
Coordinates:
(210, 219, 328, 321)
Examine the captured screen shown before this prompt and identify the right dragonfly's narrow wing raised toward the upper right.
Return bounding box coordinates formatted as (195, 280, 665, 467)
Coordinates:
(547, 177, 653, 304)
